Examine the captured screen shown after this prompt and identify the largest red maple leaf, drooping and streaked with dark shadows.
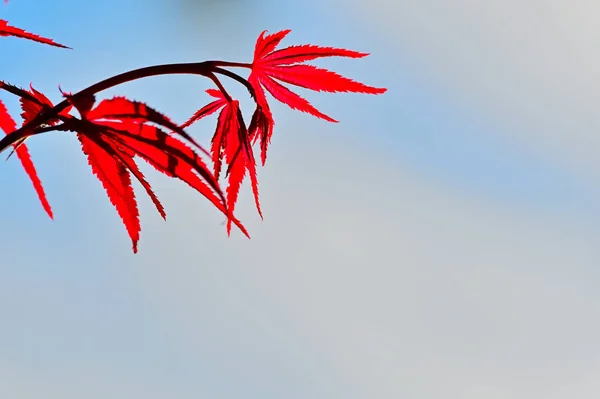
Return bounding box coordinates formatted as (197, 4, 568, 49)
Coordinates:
(68, 92, 247, 252)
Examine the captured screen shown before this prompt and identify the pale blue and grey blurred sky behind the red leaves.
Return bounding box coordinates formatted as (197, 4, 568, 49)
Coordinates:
(0, 0, 600, 399)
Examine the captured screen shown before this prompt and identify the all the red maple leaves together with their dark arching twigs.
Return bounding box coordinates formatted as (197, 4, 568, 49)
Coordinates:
(0, 1, 386, 252)
